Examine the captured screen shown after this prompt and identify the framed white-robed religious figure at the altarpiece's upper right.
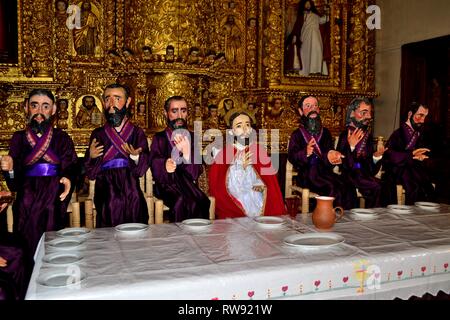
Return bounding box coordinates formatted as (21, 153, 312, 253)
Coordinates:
(281, 0, 347, 87)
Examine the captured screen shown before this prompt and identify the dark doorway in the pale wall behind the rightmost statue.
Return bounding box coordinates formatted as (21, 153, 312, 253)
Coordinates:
(400, 36, 450, 203)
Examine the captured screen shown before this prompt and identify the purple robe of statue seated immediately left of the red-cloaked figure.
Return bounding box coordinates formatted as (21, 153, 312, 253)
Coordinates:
(150, 131, 210, 222)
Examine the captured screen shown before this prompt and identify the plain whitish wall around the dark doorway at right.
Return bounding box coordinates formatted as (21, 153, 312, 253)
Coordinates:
(374, 0, 450, 138)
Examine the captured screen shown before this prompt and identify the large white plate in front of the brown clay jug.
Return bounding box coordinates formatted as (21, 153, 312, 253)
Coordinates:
(284, 232, 345, 248)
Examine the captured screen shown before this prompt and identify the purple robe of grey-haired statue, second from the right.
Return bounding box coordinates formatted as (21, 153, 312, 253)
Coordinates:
(337, 128, 381, 208)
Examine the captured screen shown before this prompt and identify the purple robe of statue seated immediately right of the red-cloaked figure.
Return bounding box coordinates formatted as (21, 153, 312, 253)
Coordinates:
(288, 128, 355, 209)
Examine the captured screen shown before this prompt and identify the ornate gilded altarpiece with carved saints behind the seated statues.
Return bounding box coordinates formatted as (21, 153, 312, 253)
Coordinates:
(0, 0, 376, 156)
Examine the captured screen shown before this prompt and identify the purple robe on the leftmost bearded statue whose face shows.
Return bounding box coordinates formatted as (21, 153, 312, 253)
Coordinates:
(4, 129, 77, 255)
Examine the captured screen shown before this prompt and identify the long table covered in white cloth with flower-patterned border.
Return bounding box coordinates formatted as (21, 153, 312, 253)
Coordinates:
(26, 205, 450, 300)
